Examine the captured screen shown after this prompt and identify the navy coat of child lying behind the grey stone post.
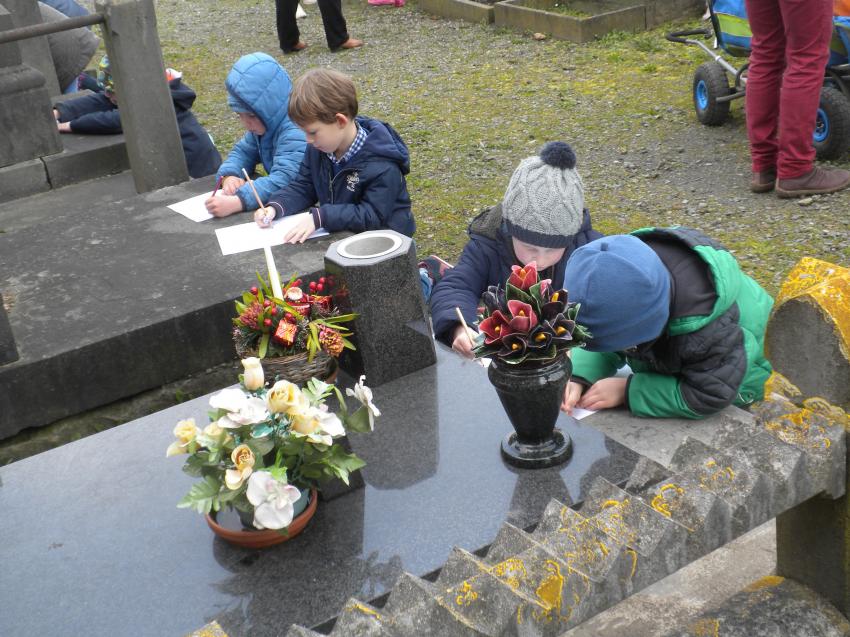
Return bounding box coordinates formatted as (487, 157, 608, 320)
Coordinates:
(54, 78, 221, 177)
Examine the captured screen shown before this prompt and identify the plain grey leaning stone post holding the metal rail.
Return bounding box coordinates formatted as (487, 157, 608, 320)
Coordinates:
(95, 0, 189, 192)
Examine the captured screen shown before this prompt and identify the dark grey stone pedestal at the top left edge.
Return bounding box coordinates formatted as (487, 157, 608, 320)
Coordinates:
(0, 5, 62, 167)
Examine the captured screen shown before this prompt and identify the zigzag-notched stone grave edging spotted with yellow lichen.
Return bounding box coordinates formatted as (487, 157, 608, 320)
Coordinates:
(291, 396, 845, 637)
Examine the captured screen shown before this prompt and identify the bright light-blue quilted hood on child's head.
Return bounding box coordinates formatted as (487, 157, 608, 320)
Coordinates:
(224, 53, 292, 137)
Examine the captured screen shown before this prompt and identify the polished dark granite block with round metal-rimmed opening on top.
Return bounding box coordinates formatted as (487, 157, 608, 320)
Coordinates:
(325, 230, 437, 386)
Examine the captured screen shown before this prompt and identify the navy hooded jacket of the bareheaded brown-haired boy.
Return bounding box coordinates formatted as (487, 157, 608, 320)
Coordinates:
(269, 116, 416, 237)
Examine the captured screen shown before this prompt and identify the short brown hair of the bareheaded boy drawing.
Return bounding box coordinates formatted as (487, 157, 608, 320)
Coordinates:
(289, 69, 357, 126)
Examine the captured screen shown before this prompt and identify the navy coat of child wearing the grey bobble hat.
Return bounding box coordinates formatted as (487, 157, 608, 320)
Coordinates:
(431, 204, 602, 345)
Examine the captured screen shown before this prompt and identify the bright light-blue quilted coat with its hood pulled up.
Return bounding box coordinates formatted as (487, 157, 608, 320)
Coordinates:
(218, 53, 307, 210)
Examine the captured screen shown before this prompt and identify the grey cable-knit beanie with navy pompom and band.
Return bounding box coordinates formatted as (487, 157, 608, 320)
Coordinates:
(502, 142, 584, 248)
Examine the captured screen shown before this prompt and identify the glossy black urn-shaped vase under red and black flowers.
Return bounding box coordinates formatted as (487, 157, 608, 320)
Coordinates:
(487, 353, 573, 469)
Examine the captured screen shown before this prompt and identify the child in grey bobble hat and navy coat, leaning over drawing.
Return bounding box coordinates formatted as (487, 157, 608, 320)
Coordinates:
(431, 142, 602, 358)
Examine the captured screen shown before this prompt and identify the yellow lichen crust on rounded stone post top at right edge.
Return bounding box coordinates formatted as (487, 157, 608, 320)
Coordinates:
(774, 257, 850, 360)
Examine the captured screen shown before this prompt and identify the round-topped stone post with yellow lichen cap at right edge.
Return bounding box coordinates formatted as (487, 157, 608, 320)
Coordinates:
(766, 258, 850, 616)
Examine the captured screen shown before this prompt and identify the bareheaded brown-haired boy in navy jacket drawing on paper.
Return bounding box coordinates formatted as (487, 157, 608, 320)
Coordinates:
(254, 69, 416, 243)
